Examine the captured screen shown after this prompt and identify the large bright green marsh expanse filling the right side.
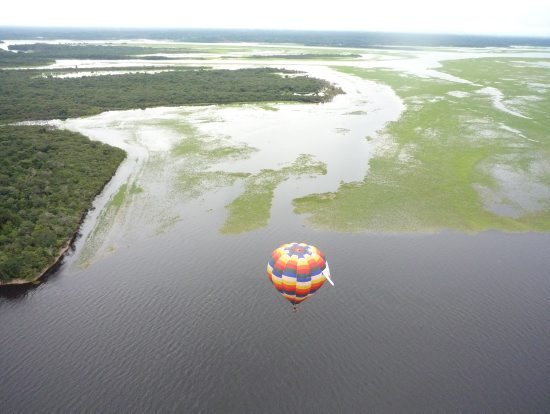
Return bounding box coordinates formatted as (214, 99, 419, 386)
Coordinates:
(293, 64, 550, 232)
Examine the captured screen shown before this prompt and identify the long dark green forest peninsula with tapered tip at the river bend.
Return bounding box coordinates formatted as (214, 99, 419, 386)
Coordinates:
(0, 68, 342, 122)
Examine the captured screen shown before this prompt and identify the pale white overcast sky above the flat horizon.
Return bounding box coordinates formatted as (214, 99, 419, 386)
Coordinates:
(0, 0, 550, 36)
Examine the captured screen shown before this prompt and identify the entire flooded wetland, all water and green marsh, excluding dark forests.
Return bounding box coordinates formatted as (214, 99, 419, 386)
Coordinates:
(0, 40, 550, 413)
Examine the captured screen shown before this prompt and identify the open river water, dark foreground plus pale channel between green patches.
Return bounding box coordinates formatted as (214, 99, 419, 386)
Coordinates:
(0, 43, 550, 413)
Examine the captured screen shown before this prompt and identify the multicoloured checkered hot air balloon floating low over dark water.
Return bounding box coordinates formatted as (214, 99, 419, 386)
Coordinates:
(267, 243, 334, 311)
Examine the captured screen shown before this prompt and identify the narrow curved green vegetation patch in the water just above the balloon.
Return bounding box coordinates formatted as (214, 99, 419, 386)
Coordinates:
(221, 154, 326, 234)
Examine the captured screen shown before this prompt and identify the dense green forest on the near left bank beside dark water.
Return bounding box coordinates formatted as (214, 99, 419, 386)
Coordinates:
(0, 126, 126, 283)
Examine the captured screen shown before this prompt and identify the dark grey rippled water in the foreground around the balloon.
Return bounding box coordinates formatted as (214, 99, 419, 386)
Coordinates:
(0, 225, 550, 413)
